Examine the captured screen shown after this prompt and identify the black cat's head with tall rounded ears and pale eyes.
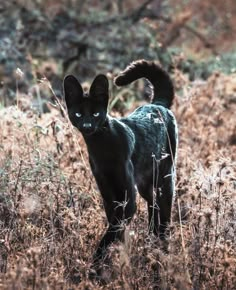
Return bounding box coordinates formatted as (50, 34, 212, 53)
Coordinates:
(64, 74, 109, 135)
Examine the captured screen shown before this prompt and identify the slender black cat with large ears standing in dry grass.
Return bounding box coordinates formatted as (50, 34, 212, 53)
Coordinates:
(64, 60, 178, 268)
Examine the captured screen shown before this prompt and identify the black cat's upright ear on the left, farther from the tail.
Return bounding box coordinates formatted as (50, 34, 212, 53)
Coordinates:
(63, 75, 83, 109)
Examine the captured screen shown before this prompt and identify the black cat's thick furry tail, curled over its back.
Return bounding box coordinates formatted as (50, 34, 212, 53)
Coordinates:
(114, 60, 174, 108)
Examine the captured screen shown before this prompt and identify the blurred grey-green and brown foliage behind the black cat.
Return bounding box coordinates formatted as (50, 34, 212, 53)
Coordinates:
(0, 0, 236, 106)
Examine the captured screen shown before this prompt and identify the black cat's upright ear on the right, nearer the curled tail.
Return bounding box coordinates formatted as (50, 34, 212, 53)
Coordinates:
(89, 74, 109, 106)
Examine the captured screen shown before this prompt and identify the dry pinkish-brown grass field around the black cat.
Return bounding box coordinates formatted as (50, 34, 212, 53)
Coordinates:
(0, 72, 236, 290)
